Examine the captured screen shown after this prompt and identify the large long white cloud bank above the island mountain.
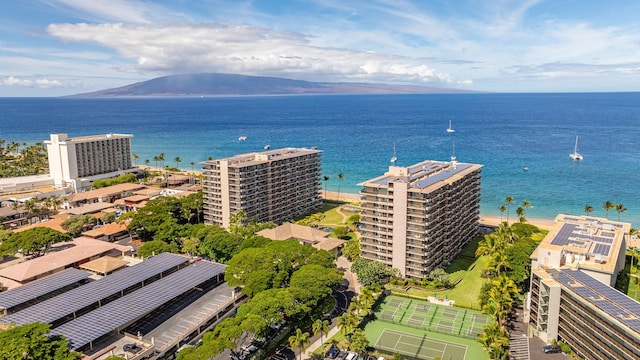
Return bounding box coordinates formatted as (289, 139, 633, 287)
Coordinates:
(47, 24, 455, 84)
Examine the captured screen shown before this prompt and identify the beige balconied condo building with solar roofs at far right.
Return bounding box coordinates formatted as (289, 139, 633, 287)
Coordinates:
(527, 214, 640, 360)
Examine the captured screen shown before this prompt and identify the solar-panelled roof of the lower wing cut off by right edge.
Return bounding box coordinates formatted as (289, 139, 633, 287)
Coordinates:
(548, 269, 640, 333)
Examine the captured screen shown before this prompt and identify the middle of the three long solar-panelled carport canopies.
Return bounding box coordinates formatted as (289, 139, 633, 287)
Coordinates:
(0, 253, 189, 326)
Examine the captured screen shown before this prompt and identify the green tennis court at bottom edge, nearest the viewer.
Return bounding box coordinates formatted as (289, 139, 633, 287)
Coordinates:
(374, 329, 467, 360)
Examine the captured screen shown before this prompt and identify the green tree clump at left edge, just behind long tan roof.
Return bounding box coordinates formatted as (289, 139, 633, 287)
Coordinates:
(0, 227, 71, 256)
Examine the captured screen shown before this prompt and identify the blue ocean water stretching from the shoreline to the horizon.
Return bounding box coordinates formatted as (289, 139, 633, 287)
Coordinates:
(0, 93, 640, 226)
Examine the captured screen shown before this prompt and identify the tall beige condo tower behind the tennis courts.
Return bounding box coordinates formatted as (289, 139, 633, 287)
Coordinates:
(358, 158, 482, 278)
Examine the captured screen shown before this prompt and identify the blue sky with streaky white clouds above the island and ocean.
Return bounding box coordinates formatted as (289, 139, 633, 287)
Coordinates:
(0, 0, 640, 97)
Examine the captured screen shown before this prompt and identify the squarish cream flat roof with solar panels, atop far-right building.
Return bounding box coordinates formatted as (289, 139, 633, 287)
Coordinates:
(531, 214, 631, 274)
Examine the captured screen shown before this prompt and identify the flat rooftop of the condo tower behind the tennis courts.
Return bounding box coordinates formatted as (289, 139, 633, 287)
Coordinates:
(358, 160, 482, 192)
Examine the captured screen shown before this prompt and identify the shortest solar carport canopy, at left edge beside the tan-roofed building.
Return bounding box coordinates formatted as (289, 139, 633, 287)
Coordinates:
(0, 268, 91, 310)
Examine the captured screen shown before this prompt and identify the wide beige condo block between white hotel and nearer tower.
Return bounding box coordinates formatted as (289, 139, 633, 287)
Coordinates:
(203, 148, 322, 227)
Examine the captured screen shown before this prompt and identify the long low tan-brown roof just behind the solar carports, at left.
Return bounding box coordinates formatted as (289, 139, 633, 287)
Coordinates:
(0, 236, 131, 282)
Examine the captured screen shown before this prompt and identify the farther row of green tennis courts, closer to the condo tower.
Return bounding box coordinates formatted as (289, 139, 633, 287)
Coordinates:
(376, 296, 490, 339)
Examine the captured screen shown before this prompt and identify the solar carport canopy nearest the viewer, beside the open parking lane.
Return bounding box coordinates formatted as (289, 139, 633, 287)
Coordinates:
(51, 261, 225, 350)
